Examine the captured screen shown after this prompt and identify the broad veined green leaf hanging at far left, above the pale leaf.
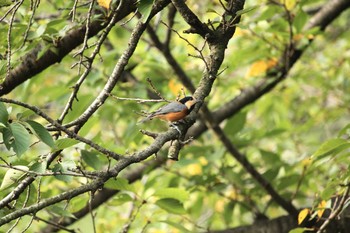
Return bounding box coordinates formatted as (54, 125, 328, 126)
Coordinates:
(3, 122, 30, 156)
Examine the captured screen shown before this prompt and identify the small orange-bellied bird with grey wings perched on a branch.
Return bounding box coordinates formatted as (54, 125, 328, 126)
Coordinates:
(138, 96, 197, 132)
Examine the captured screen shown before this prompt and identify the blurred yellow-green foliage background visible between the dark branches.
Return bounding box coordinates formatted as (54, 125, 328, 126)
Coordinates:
(0, 0, 350, 232)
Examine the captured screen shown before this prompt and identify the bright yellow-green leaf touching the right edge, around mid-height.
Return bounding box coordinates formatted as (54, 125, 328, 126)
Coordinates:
(313, 138, 350, 158)
